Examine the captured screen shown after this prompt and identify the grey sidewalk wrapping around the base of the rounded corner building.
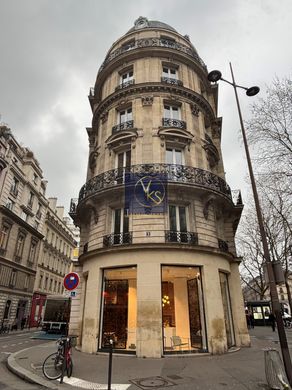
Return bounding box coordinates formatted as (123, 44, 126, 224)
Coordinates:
(7, 327, 292, 390)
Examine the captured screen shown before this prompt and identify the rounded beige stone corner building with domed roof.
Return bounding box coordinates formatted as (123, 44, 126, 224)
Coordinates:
(70, 17, 249, 357)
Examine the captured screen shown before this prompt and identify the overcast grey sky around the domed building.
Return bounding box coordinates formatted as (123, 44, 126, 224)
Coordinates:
(0, 0, 292, 215)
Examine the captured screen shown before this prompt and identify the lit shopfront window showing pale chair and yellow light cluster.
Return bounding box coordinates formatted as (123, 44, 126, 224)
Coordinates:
(161, 266, 207, 353)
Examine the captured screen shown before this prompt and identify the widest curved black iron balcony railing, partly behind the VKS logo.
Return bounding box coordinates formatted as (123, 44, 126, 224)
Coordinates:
(78, 163, 232, 203)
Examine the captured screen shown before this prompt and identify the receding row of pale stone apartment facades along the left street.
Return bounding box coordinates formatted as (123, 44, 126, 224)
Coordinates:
(0, 124, 76, 329)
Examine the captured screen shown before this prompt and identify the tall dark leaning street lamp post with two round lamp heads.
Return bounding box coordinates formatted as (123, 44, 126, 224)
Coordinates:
(208, 63, 292, 385)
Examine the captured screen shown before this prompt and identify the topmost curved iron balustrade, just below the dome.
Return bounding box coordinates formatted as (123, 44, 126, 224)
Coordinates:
(98, 37, 207, 73)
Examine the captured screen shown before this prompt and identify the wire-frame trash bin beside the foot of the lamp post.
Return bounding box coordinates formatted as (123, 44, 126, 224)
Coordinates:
(264, 348, 291, 390)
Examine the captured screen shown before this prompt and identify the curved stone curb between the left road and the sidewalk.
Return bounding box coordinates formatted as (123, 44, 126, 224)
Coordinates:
(6, 348, 58, 390)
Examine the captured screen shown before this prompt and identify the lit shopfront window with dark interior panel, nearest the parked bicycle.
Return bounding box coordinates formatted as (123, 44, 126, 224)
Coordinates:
(99, 267, 137, 351)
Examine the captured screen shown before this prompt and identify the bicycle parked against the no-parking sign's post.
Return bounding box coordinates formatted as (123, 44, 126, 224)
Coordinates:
(43, 337, 75, 381)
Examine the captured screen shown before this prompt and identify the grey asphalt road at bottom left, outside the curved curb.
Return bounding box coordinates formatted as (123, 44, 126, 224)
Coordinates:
(0, 332, 48, 390)
